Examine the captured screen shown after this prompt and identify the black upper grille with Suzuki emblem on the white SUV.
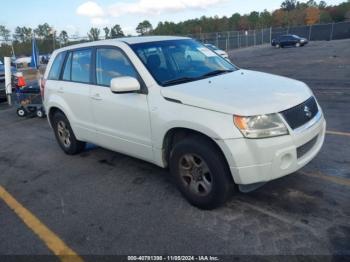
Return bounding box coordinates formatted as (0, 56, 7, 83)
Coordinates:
(280, 96, 318, 129)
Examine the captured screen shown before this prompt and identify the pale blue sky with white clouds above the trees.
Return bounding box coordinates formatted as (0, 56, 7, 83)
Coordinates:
(0, 0, 345, 36)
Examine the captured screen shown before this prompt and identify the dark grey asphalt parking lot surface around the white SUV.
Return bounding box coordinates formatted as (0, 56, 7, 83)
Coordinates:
(0, 40, 350, 260)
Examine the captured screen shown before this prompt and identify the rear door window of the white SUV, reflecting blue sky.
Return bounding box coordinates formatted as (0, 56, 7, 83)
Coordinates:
(71, 49, 92, 83)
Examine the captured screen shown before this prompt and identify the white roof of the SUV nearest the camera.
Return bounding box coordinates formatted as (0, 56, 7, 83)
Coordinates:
(55, 36, 190, 53)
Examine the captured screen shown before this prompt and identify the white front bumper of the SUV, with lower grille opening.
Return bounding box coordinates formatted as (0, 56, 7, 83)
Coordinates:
(218, 111, 326, 184)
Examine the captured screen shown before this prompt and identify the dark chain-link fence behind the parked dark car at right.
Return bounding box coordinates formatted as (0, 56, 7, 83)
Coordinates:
(190, 22, 350, 50)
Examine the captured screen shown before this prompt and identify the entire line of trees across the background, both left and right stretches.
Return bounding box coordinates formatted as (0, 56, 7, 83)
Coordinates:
(0, 0, 350, 57)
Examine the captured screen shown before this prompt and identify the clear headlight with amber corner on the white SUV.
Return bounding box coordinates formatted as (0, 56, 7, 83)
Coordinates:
(233, 114, 288, 138)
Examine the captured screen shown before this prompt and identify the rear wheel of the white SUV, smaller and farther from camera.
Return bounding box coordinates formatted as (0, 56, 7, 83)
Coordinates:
(52, 112, 86, 155)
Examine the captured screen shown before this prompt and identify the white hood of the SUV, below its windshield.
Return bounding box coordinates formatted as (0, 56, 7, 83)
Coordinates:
(161, 70, 312, 116)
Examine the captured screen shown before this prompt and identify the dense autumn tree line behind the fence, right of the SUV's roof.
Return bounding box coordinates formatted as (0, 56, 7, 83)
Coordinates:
(152, 0, 350, 35)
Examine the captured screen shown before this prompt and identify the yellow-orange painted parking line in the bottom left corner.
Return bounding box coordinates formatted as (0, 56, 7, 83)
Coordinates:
(0, 185, 84, 262)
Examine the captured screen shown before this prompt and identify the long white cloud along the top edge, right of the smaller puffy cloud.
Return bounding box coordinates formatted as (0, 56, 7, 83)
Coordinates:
(108, 0, 227, 16)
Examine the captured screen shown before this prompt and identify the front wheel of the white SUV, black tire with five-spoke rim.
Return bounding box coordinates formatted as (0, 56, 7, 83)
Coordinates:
(169, 137, 233, 210)
